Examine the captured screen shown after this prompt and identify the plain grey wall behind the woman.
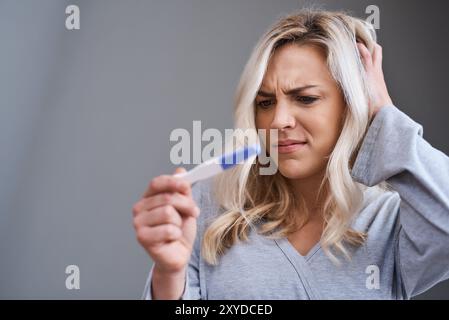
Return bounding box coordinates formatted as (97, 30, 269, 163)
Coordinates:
(0, 0, 449, 299)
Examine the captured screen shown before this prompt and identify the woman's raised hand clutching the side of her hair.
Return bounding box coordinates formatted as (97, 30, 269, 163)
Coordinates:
(357, 42, 393, 119)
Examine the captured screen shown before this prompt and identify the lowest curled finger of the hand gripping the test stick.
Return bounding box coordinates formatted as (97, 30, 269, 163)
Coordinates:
(136, 224, 182, 247)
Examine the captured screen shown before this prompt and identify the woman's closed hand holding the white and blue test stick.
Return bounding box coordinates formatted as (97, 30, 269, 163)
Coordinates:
(133, 168, 200, 277)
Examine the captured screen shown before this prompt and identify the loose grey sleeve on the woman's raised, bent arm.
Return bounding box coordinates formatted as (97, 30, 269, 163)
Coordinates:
(352, 105, 449, 297)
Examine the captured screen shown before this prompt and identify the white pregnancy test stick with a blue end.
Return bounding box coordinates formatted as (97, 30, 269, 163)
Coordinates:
(175, 144, 260, 184)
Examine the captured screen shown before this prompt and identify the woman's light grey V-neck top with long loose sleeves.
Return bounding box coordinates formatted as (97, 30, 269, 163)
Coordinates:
(143, 105, 449, 299)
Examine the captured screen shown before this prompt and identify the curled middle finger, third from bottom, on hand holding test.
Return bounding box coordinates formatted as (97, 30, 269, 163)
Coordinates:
(133, 193, 199, 218)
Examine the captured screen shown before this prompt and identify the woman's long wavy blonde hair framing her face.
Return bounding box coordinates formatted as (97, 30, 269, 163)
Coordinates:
(201, 9, 388, 264)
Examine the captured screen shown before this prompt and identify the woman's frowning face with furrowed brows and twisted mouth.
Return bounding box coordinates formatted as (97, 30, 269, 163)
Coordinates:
(256, 44, 346, 179)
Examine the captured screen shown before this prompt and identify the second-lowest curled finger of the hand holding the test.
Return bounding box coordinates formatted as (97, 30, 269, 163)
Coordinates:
(134, 205, 182, 229)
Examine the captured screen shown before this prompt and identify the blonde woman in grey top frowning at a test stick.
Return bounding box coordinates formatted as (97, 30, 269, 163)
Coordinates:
(133, 10, 449, 299)
